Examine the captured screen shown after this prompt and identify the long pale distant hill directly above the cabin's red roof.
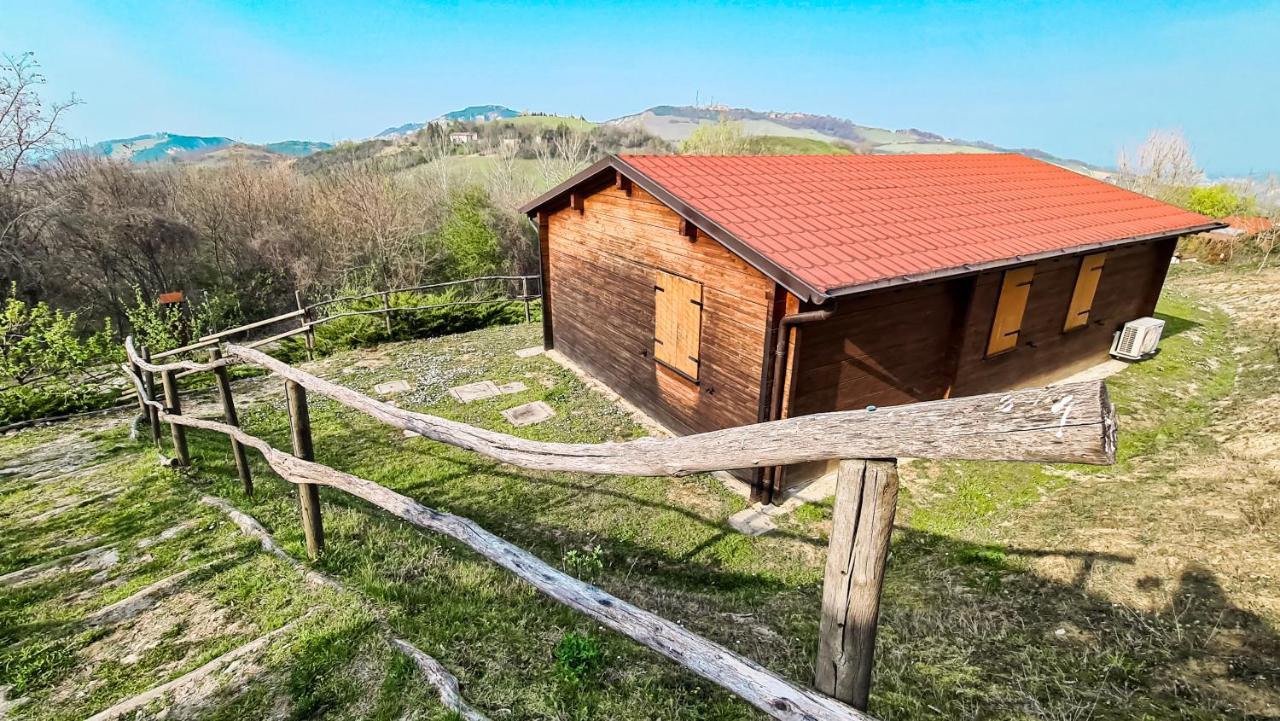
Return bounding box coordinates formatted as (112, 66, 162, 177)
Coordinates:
(608, 105, 1103, 174)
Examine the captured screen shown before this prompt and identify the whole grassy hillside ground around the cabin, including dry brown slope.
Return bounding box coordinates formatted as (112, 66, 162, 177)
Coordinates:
(0, 264, 1280, 721)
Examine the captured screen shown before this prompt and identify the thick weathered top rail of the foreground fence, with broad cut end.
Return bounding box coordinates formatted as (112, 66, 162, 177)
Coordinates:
(222, 344, 1116, 475)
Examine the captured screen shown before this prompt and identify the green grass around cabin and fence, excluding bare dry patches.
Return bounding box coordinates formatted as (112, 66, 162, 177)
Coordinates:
(0, 267, 1270, 721)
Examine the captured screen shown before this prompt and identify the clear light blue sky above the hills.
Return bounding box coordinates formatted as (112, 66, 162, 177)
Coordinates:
(0, 0, 1280, 175)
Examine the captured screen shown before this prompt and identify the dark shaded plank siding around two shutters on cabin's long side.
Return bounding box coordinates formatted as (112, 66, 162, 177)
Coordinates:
(794, 241, 1175, 415)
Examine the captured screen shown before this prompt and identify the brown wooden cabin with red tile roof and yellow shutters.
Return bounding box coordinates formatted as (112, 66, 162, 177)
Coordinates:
(522, 154, 1221, 501)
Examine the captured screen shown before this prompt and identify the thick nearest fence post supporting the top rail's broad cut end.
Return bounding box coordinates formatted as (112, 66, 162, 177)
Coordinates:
(814, 460, 897, 711)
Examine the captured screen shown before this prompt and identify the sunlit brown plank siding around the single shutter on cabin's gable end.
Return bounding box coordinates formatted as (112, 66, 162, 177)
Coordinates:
(547, 187, 773, 433)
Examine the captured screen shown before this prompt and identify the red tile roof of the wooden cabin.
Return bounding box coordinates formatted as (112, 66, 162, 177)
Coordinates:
(619, 154, 1215, 295)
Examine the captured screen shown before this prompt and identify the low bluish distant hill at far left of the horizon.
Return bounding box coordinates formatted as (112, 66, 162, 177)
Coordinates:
(84, 132, 330, 164)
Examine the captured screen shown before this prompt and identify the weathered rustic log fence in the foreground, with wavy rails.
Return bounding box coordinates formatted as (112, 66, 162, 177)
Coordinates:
(122, 338, 1116, 721)
